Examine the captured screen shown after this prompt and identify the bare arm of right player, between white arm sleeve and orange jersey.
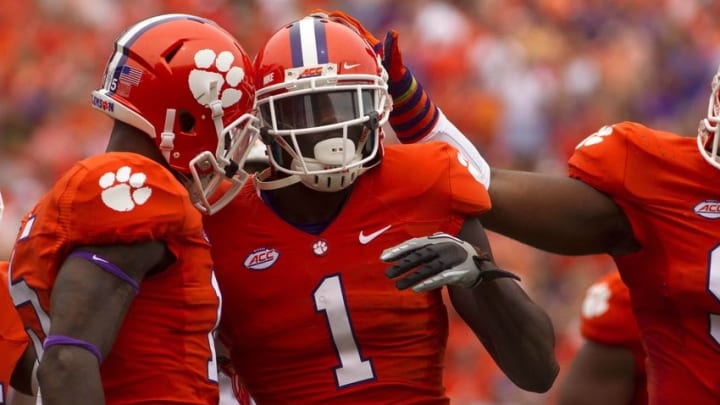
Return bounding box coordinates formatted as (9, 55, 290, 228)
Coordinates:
(480, 169, 632, 255)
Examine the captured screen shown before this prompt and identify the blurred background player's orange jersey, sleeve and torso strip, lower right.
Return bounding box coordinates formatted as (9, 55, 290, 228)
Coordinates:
(580, 271, 647, 405)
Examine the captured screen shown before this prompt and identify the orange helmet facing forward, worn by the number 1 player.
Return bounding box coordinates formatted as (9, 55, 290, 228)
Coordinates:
(254, 15, 392, 192)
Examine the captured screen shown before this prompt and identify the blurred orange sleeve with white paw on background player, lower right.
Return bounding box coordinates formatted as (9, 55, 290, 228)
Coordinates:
(580, 272, 640, 346)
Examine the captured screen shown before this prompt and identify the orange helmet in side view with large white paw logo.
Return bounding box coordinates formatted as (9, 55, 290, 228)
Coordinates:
(92, 14, 258, 214)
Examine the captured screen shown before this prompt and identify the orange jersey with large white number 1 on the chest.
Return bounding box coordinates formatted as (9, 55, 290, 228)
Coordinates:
(205, 143, 490, 404)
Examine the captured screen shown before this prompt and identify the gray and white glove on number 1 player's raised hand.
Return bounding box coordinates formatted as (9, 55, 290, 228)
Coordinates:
(380, 233, 520, 292)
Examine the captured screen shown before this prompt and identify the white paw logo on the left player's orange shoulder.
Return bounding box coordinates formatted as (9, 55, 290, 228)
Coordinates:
(98, 166, 152, 212)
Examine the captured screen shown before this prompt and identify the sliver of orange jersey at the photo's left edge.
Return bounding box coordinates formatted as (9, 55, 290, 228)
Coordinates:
(0, 262, 29, 404)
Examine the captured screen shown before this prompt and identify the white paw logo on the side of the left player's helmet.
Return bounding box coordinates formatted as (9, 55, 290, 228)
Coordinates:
(188, 49, 245, 108)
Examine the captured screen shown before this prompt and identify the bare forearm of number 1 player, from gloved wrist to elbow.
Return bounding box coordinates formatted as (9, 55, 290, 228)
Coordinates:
(450, 278, 559, 392)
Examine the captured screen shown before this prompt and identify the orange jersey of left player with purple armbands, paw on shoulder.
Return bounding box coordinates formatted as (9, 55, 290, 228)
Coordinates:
(10, 153, 219, 404)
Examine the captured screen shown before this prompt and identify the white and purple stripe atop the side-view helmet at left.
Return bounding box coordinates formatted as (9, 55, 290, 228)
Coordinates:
(103, 14, 209, 92)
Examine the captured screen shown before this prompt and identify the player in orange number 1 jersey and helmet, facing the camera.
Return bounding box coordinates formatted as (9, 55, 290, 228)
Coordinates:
(205, 16, 558, 404)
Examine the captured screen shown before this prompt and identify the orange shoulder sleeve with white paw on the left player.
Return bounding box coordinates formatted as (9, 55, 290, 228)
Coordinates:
(57, 154, 199, 244)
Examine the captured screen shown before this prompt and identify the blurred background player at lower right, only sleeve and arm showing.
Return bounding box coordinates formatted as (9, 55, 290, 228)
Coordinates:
(558, 272, 647, 405)
